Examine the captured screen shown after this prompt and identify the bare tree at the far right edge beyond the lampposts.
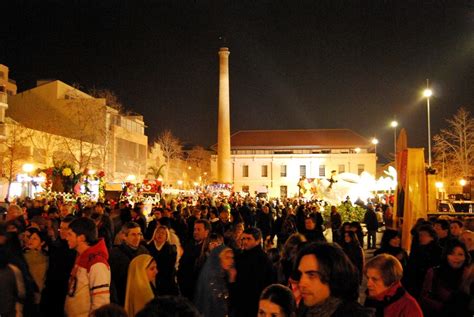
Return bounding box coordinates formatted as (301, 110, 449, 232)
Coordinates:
(433, 108, 474, 189)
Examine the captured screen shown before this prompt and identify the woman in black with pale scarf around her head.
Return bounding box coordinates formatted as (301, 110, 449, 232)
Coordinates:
(147, 225, 179, 296)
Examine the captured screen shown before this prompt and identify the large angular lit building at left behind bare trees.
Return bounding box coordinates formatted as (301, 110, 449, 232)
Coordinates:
(8, 80, 148, 182)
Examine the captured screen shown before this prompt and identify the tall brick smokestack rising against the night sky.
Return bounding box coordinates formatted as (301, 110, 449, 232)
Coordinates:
(217, 47, 232, 183)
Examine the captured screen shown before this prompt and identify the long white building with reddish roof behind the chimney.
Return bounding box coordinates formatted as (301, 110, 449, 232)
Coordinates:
(211, 129, 376, 197)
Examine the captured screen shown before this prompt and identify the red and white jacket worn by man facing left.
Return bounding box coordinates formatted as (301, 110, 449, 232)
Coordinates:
(64, 239, 110, 317)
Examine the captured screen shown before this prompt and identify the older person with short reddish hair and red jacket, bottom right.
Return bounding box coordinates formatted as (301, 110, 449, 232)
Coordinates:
(364, 253, 423, 317)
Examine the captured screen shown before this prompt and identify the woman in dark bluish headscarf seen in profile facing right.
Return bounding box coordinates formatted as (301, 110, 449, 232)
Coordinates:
(194, 245, 236, 317)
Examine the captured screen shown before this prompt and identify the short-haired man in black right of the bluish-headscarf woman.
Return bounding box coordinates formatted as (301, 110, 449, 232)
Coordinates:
(234, 228, 274, 317)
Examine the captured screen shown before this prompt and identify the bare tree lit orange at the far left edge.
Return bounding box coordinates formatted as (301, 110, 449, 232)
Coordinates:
(0, 119, 30, 198)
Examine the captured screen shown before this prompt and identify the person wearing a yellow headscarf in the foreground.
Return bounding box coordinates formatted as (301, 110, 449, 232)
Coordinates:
(124, 254, 158, 316)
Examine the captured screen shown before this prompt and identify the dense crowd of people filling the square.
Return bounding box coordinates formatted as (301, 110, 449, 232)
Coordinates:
(0, 196, 474, 317)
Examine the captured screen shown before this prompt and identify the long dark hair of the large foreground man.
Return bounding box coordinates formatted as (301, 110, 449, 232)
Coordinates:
(295, 242, 359, 300)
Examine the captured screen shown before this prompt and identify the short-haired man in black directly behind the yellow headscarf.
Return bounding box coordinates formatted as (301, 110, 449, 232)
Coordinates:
(110, 222, 149, 305)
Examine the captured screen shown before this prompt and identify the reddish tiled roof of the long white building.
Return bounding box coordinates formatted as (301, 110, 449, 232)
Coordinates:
(230, 129, 373, 149)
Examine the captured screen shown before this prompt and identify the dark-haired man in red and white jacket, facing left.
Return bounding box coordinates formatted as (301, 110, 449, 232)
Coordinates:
(64, 218, 110, 317)
